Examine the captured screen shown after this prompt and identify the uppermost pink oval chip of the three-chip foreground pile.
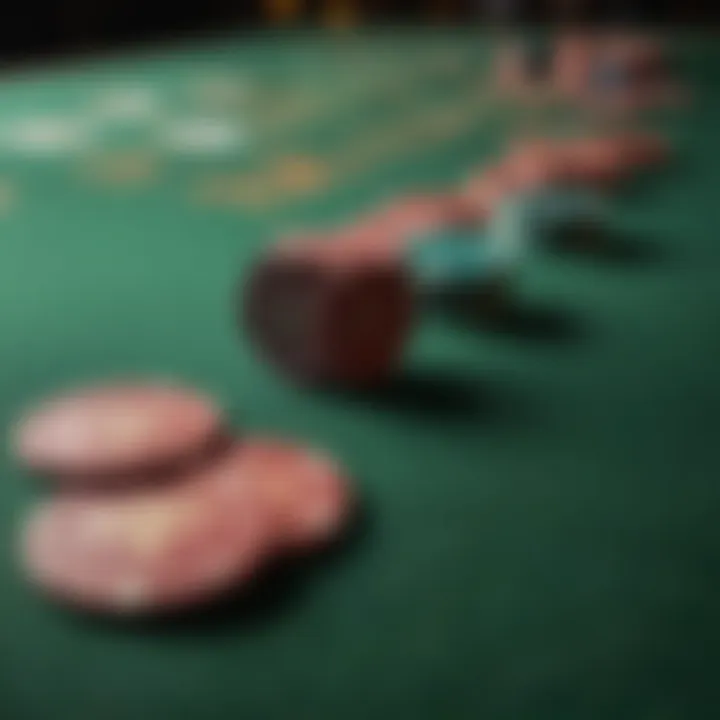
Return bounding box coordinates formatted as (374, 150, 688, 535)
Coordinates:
(14, 384, 221, 483)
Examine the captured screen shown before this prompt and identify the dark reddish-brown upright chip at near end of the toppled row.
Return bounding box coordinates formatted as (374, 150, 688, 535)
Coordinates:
(239, 236, 413, 386)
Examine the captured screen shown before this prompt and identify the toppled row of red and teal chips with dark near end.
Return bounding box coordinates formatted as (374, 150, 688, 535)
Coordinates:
(245, 134, 667, 389)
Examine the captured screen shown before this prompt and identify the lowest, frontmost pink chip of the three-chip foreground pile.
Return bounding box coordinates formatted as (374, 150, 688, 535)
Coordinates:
(20, 472, 269, 615)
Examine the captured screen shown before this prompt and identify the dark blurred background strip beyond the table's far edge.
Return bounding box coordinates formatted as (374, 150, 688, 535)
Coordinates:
(0, 0, 720, 63)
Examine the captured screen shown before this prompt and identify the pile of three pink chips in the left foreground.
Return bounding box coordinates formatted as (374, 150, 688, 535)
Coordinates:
(14, 382, 352, 615)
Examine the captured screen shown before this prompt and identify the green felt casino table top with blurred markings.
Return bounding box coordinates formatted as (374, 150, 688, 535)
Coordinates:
(0, 32, 720, 720)
